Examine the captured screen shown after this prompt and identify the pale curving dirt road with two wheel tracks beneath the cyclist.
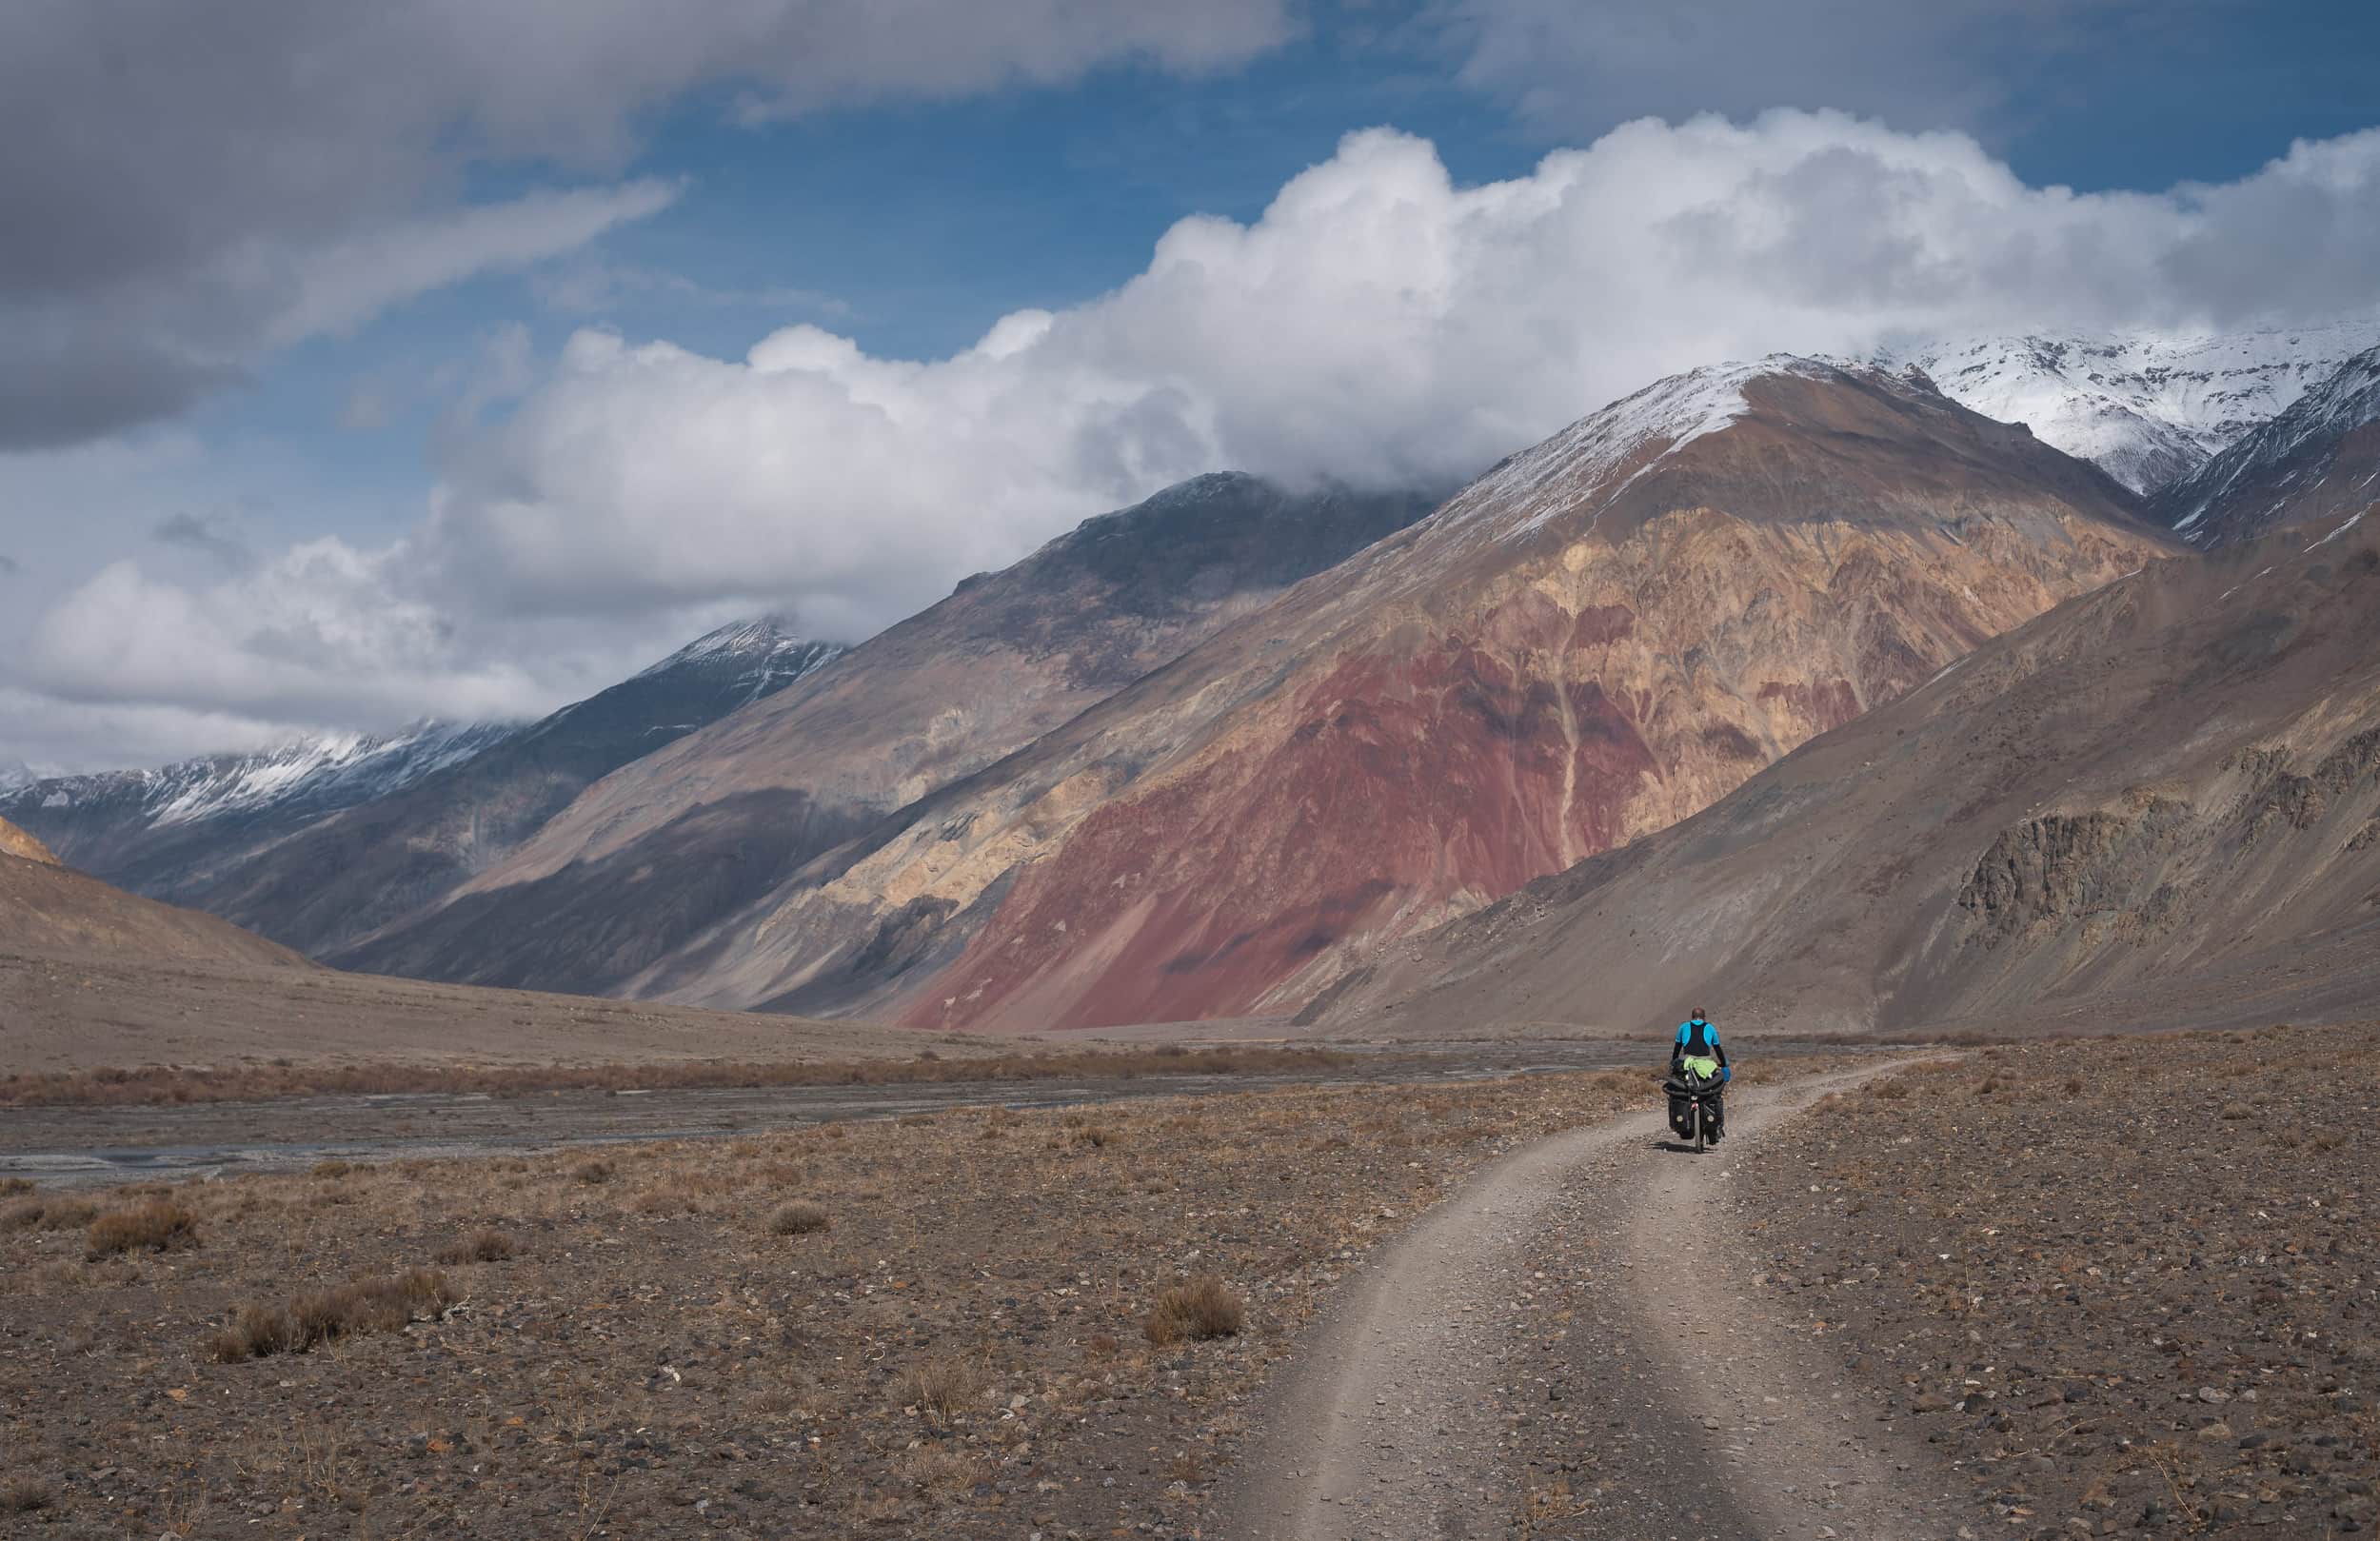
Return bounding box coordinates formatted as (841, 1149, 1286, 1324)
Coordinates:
(1219, 1065, 1971, 1541)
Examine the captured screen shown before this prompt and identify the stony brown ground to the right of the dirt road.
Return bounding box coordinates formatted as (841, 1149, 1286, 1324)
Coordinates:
(1737, 1027, 2380, 1536)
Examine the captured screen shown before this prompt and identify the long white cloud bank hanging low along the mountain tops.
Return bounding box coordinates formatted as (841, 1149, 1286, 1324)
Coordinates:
(24, 111, 2380, 770)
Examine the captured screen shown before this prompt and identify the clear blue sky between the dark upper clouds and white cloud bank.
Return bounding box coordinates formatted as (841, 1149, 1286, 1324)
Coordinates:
(219, 2, 2380, 451)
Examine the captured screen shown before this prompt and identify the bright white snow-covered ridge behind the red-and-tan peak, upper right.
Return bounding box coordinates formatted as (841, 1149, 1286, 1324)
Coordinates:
(1875, 316, 2380, 492)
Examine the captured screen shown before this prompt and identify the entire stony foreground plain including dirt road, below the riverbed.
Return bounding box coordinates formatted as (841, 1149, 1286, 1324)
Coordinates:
(0, 1027, 2380, 1541)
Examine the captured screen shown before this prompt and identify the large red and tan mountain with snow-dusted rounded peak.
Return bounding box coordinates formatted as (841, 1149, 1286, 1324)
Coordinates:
(685, 362, 2171, 1027)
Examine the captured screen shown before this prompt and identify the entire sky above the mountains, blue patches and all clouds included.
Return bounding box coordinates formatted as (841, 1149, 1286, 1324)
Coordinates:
(0, 0, 2380, 766)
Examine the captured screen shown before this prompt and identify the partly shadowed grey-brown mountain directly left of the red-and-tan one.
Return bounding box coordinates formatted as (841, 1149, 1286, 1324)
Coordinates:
(331, 473, 1436, 992)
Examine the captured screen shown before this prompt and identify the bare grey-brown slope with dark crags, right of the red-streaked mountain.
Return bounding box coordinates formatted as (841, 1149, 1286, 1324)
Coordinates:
(1321, 502, 2380, 1032)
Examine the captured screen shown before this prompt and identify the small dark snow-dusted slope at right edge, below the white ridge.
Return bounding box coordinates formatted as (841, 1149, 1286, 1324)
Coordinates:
(2152, 347, 2380, 547)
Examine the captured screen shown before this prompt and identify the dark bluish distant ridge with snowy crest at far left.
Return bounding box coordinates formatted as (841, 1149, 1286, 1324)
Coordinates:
(0, 621, 841, 951)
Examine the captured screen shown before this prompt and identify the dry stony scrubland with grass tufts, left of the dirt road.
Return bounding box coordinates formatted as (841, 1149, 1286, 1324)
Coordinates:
(0, 1073, 1655, 1541)
